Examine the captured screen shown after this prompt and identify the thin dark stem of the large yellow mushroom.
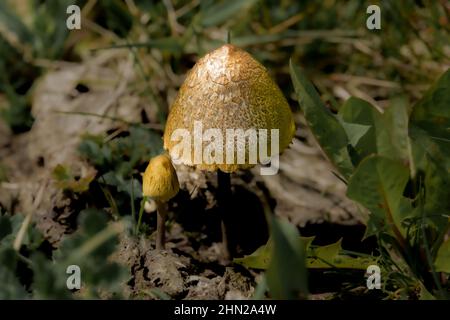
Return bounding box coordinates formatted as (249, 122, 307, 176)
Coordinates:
(217, 170, 232, 262)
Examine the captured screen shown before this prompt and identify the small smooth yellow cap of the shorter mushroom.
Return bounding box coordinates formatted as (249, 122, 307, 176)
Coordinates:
(142, 154, 180, 202)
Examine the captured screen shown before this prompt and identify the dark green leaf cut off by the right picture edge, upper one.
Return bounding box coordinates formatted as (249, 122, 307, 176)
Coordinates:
(409, 70, 450, 237)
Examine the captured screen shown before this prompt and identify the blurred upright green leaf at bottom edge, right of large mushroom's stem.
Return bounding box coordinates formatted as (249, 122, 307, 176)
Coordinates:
(266, 217, 308, 299)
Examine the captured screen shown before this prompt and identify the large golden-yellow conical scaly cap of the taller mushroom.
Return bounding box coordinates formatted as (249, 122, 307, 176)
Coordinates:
(164, 44, 295, 172)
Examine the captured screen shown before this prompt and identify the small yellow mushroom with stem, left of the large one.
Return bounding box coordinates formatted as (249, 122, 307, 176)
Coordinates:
(142, 154, 180, 250)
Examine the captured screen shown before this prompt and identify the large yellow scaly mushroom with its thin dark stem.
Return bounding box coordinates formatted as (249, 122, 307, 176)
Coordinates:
(164, 44, 295, 257)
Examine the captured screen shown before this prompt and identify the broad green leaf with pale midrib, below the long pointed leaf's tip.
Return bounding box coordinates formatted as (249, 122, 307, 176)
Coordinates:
(347, 156, 413, 235)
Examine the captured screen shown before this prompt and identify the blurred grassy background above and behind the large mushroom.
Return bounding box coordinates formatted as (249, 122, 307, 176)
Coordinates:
(0, 0, 450, 133)
